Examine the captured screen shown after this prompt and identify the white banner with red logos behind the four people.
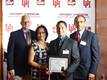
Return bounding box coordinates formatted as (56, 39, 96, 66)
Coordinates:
(2, 0, 95, 50)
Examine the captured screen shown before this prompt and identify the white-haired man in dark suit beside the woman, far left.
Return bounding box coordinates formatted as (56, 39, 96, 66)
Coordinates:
(7, 15, 35, 80)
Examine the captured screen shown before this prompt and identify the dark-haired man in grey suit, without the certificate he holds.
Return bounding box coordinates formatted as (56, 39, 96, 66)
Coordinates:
(48, 21, 80, 80)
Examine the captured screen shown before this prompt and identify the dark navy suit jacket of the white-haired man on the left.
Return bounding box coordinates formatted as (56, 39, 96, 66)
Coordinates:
(7, 29, 35, 76)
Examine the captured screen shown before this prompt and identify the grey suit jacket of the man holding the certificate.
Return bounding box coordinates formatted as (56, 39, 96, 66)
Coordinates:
(48, 36, 80, 80)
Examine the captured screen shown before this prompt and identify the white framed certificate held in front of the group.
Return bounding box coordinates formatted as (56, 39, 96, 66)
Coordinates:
(49, 57, 68, 72)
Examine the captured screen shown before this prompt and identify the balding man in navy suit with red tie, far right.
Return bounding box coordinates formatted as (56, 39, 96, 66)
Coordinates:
(70, 15, 100, 80)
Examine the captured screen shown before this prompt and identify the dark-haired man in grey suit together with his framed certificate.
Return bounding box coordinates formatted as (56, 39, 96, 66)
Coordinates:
(48, 21, 80, 80)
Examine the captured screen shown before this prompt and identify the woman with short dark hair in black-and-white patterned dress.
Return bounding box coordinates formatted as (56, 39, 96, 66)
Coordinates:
(28, 25, 48, 80)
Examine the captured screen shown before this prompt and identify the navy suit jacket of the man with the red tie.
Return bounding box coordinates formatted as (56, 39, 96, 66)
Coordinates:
(70, 30, 100, 80)
